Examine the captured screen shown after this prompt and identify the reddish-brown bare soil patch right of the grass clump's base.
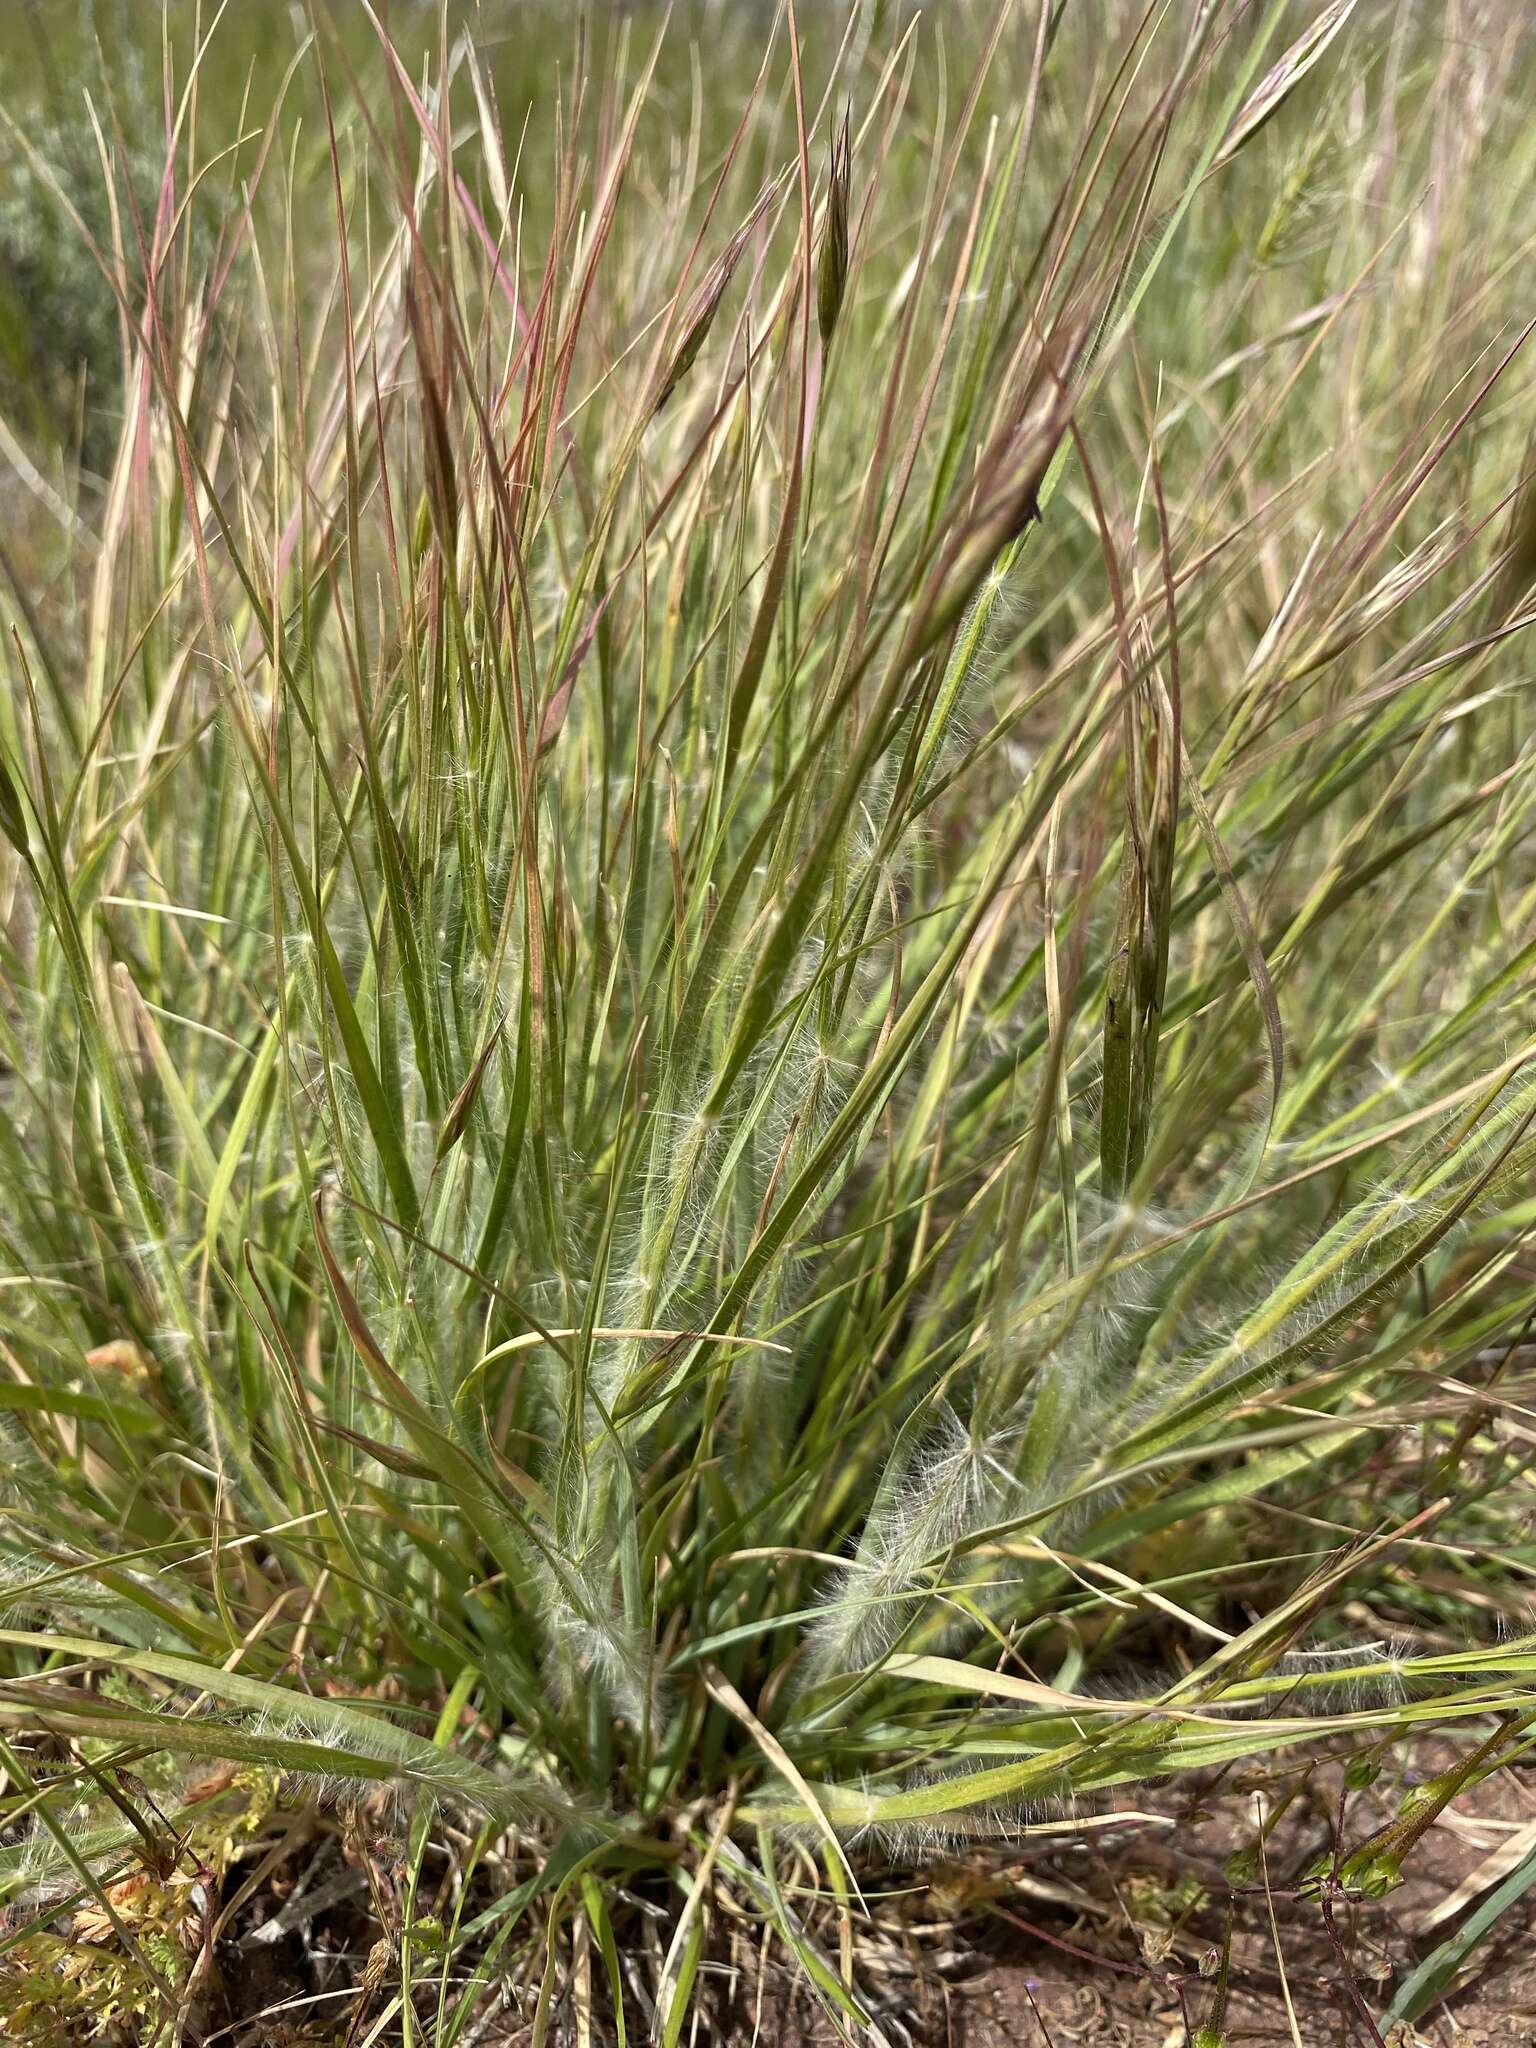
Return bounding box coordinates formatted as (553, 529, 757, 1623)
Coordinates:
(760, 1747, 1536, 2048)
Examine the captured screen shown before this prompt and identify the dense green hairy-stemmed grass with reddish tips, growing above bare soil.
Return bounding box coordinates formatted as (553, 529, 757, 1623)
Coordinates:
(0, 4, 1536, 2048)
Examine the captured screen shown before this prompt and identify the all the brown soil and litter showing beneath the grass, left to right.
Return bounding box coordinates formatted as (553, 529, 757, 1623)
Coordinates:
(15, 1741, 1536, 2048)
